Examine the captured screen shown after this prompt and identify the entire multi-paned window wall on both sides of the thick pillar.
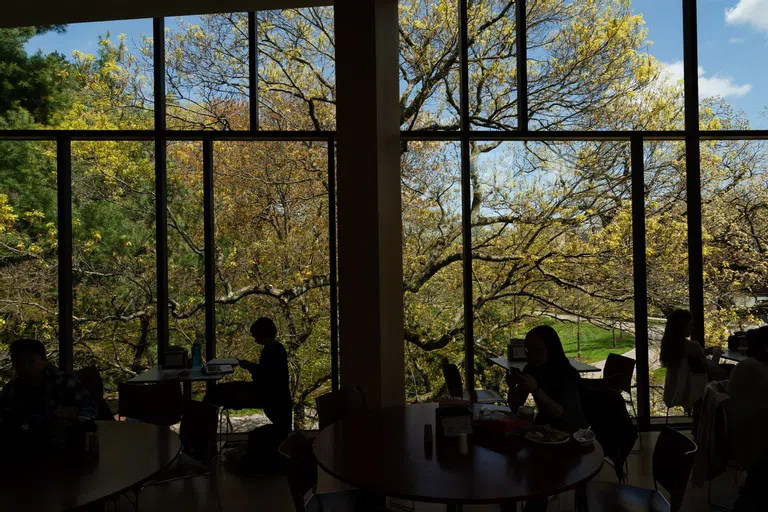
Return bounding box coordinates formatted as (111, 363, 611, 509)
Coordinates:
(0, 0, 768, 426)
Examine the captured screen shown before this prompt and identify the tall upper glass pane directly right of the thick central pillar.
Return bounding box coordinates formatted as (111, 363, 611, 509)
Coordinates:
(399, 0, 459, 130)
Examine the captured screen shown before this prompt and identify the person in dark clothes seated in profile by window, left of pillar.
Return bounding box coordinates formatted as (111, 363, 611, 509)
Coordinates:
(203, 317, 291, 432)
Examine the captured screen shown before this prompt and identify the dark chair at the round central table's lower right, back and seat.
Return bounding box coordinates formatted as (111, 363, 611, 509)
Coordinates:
(586, 427, 698, 512)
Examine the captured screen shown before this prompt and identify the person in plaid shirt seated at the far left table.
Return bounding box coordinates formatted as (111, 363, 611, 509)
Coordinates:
(0, 338, 97, 452)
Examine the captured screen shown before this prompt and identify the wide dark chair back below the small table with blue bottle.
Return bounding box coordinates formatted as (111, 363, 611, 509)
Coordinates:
(117, 379, 184, 426)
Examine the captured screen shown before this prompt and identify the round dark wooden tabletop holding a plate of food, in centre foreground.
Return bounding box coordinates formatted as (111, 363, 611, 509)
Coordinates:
(314, 404, 604, 505)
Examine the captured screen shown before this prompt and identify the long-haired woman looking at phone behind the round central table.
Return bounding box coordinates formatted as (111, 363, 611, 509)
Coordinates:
(507, 325, 588, 432)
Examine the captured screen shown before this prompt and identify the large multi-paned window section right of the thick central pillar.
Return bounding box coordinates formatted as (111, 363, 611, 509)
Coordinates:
(400, 0, 768, 423)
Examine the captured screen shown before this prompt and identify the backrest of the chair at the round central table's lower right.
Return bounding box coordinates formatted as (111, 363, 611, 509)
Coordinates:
(653, 427, 698, 512)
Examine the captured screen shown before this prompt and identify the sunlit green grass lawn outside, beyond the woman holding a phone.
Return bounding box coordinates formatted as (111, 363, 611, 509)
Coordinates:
(542, 319, 635, 363)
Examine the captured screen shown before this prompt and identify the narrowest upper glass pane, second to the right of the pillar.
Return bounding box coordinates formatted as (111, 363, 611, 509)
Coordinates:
(467, 0, 517, 130)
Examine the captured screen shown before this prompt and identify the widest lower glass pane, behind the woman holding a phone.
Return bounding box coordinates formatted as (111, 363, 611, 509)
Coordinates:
(472, 142, 635, 396)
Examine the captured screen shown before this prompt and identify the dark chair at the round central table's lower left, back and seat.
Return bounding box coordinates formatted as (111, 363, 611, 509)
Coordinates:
(280, 432, 386, 512)
